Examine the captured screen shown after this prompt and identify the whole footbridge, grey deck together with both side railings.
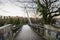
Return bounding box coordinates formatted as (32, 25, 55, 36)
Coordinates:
(0, 24, 60, 40)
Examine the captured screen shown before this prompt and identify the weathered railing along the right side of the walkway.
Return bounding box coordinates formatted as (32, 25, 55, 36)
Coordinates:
(31, 25, 60, 40)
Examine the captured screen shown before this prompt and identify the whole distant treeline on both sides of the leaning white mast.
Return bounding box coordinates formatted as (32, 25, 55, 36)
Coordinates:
(0, 16, 42, 26)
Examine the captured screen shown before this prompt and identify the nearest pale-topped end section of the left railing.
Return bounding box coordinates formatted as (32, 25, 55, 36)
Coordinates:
(0, 24, 12, 40)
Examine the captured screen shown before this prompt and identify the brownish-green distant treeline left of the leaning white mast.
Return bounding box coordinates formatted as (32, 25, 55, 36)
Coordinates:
(0, 16, 28, 26)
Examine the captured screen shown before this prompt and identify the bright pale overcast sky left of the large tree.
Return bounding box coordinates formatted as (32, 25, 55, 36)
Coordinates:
(0, 0, 35, 17)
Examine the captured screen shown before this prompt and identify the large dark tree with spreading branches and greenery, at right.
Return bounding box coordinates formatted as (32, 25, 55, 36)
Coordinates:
(34, 0, 60, 24)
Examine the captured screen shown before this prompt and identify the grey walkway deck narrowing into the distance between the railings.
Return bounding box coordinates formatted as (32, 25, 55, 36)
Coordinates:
(15, 25, 43, 40)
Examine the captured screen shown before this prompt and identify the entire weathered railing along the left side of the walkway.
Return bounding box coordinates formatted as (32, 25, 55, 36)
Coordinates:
(0, 24, 22, 40)
